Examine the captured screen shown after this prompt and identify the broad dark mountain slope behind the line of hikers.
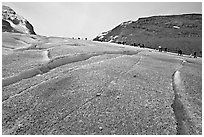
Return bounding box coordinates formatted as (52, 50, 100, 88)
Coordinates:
(93, 14, 202, 55)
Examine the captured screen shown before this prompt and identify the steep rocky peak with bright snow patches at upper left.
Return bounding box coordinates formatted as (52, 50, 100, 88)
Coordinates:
(2, 5, 36, 35)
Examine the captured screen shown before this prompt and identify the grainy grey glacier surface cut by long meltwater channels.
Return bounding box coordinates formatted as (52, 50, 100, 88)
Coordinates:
(2, 32, 202, 135)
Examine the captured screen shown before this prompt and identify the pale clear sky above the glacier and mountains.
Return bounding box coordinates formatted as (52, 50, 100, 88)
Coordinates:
(2, 2, 202, 39)
